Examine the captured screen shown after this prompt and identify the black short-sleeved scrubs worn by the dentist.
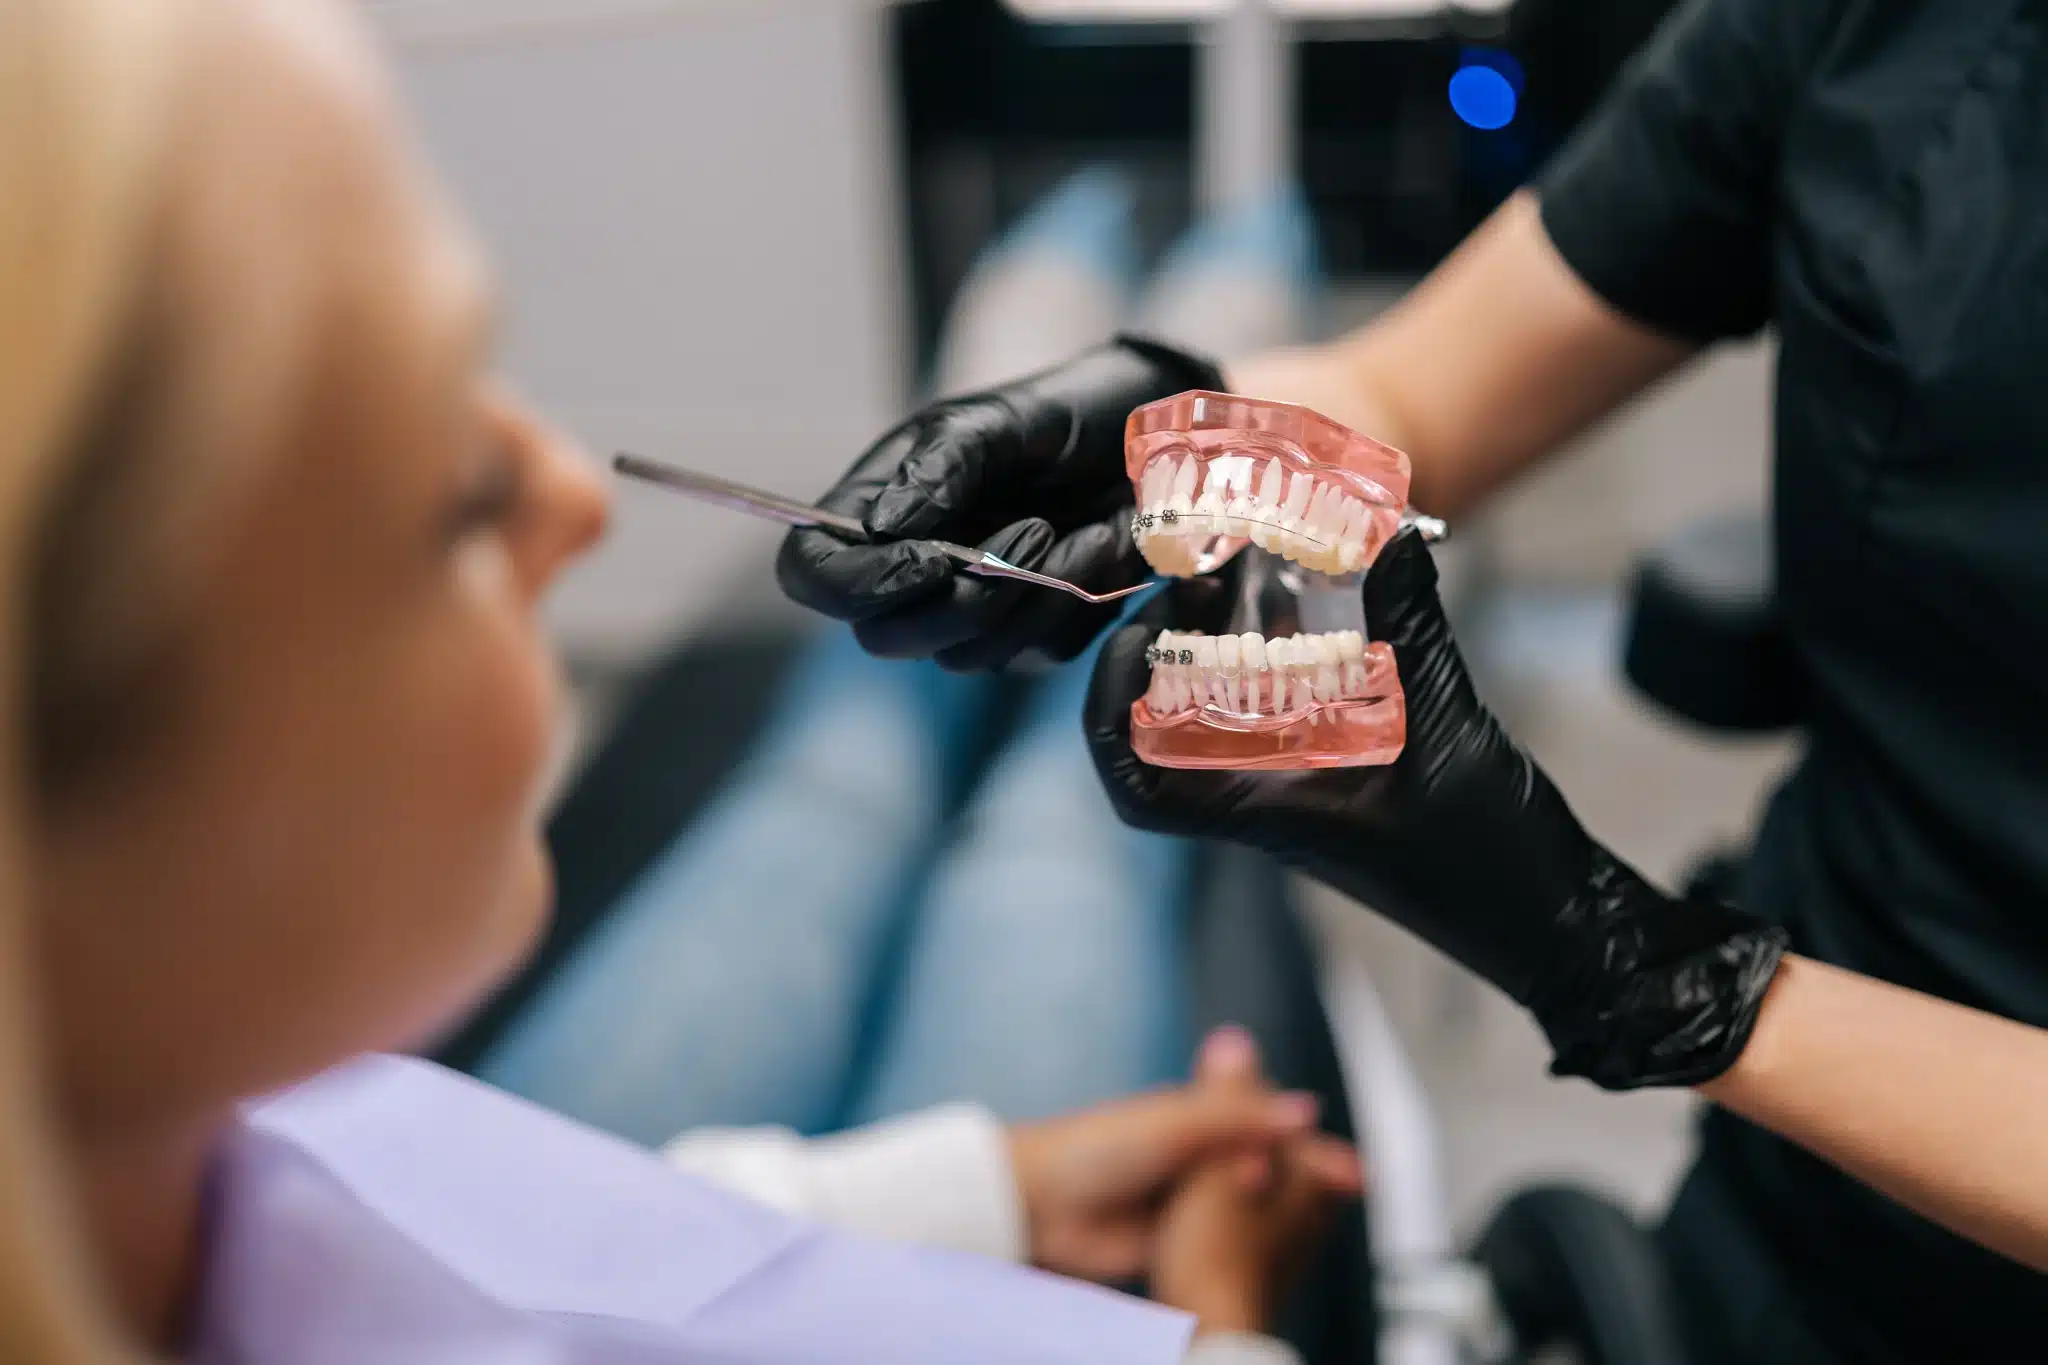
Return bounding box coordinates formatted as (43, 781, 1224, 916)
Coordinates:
(1540, 0, 2048, 1365)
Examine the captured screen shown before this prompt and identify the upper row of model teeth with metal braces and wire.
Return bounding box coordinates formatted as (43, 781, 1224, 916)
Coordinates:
(1133, 454, 1372, 575)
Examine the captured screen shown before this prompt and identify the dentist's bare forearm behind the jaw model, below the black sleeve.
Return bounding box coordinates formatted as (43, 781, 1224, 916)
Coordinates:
(1225, 190, 1696, 516)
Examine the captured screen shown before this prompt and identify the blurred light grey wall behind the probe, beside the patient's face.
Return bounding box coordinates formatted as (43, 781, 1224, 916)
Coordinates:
(373, 0, 907, 657)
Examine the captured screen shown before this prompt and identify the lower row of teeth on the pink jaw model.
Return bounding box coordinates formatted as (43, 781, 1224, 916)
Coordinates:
(1145, 630, 1370, 716)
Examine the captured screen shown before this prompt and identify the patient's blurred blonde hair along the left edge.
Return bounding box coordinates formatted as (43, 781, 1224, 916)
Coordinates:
(0, 0, 190, 1365)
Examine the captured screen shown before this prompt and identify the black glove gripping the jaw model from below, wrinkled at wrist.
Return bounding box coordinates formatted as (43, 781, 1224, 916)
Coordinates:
(1087, 532, 1786, 1091)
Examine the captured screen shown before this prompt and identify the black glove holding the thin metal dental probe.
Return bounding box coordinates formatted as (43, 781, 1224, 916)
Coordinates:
(776, 338, 1223, 671)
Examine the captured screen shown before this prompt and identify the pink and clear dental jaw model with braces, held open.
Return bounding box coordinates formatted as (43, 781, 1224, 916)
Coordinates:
(1124, 393, 1409, 769)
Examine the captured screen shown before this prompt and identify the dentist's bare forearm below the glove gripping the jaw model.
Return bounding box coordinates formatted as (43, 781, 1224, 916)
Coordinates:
(1700, 958, 2048, 1271)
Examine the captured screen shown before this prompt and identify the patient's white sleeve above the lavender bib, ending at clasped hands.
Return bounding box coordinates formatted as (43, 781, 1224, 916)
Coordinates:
(664, 1105, 1026, 1261)
